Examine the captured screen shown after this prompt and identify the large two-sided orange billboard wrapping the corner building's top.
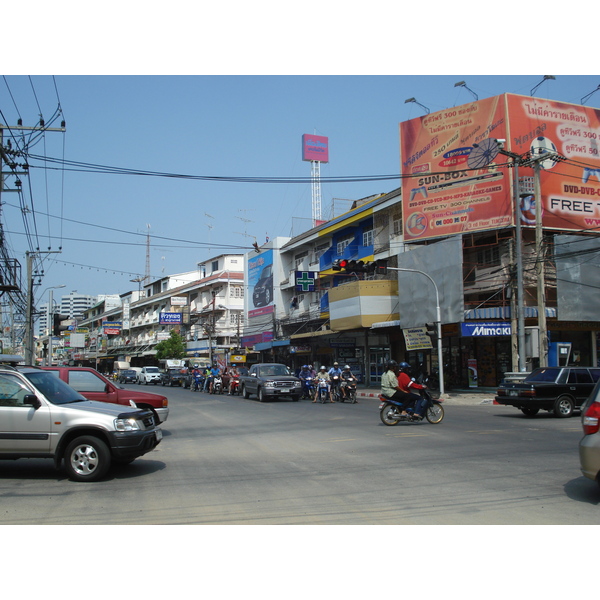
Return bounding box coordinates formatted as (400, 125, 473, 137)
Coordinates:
(400, 94, 600, 241)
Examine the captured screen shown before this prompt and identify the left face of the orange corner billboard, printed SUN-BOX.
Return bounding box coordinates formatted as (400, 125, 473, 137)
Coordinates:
(400, 96, 514, 241)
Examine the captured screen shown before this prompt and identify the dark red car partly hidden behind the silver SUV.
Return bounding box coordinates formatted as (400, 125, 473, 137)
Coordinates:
(40, 367, 169, 423)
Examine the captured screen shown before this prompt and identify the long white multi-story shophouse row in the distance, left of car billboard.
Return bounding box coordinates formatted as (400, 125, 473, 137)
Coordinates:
(71, 254, 244, 372)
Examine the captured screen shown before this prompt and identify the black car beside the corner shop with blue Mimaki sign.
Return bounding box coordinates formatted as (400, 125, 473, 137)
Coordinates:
(495, 367, 600, 418)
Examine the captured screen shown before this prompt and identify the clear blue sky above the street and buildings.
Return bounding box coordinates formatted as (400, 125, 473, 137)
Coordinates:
(0, 75, 600, 304)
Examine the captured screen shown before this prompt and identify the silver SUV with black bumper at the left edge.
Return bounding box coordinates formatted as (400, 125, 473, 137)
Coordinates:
(0, 366, 162, 481)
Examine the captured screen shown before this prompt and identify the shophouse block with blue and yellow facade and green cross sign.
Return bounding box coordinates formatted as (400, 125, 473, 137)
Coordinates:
(244, 190, 401, 383)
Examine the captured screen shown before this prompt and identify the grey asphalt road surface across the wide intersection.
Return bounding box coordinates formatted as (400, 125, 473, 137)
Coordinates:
(0, 388, 600, 525)
